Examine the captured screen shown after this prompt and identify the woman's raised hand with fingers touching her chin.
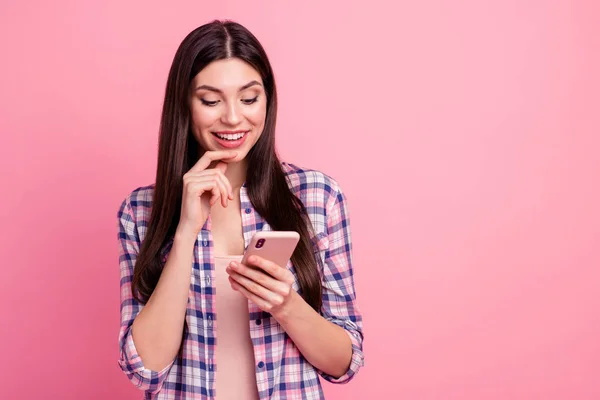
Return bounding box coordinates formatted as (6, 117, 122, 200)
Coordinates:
(177, 151, 237, 236)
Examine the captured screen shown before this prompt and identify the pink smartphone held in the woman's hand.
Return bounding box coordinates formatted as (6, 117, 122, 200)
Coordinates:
(242, 231, 300, 268)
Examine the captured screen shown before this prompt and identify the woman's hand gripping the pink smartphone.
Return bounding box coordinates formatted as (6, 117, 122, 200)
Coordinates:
(226, 255, 297, 319)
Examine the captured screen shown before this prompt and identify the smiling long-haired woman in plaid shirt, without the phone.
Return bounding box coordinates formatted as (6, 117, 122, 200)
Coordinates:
(118, 21, 363, 400)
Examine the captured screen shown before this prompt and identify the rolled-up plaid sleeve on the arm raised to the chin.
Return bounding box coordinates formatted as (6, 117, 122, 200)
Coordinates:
(118, 199, 173, 393)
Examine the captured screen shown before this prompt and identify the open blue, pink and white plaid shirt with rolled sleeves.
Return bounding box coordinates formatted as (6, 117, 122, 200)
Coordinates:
(118, 163, 364, 400)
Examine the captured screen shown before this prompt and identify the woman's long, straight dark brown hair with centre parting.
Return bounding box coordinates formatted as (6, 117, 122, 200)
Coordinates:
(132, 21, 322, 311)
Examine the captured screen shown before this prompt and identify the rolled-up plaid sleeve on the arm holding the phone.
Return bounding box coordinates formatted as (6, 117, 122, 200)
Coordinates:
(320, 184, 364, 383)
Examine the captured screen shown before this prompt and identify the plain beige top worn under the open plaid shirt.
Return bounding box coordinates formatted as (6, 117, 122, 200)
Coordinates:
(215, 256, 258, 400)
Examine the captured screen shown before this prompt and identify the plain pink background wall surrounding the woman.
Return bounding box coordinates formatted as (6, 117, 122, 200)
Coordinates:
(0, 0, 600, 400)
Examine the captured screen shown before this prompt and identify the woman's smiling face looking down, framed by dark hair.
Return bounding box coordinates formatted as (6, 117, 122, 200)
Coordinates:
(190, 58, 267, 162)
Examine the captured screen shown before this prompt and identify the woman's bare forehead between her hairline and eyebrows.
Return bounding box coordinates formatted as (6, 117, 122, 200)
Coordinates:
(193, 58, 262, 91)
